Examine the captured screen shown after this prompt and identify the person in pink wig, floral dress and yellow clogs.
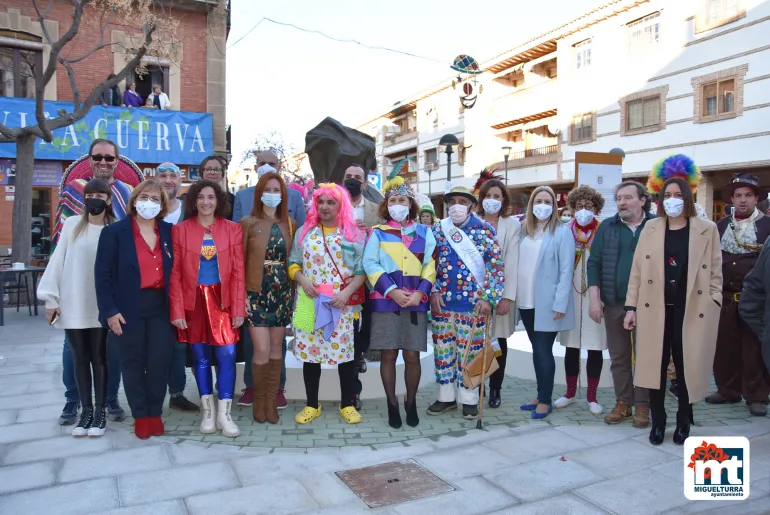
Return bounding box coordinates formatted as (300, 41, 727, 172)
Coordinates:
(289, 183, 366, 424)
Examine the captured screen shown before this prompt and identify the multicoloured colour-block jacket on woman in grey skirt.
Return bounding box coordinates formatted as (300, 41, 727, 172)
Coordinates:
(363, 222, 436, 312)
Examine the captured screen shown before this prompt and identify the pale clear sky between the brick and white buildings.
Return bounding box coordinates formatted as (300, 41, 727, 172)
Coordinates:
(227, 0, 609, 166)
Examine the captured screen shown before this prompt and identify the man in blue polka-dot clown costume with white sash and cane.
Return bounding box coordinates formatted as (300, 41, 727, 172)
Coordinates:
(428, 186, 504, 420)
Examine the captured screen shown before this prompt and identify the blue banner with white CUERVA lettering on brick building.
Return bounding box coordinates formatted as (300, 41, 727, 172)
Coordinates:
(0, 97, 214, 165)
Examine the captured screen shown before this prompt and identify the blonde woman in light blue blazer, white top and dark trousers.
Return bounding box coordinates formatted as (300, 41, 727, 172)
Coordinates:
(516, 186, 575, 419)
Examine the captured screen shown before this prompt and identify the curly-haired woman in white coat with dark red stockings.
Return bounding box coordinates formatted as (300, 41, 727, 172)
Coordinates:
(553, 185, 607, 415)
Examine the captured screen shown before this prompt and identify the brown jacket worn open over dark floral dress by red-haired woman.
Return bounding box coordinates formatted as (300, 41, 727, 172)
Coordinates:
(241, 216, 297, 293)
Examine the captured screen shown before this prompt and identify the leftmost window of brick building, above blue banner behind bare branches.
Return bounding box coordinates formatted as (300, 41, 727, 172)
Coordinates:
(0, 36, 43, 98)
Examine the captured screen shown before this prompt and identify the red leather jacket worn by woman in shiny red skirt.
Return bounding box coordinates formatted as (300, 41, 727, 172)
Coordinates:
(169, 217, 246, 320)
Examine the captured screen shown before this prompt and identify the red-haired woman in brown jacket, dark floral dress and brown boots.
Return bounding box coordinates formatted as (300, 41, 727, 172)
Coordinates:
(241, 172, 297, 424)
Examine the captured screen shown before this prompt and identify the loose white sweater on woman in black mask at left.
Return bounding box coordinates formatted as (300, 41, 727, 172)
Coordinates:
(37, 215, 104, 329)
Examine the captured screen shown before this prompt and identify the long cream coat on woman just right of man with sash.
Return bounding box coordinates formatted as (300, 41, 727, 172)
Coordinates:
(491, 216, 521, 338)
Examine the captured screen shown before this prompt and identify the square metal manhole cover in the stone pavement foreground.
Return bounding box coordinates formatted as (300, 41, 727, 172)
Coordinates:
(336, 460, 454, 508)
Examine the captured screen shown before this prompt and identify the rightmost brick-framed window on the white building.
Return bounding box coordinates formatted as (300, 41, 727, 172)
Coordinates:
(692, 65, 748, 123)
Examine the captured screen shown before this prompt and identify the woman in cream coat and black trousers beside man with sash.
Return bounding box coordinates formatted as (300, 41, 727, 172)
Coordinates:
(475, 175, 521, 408)
